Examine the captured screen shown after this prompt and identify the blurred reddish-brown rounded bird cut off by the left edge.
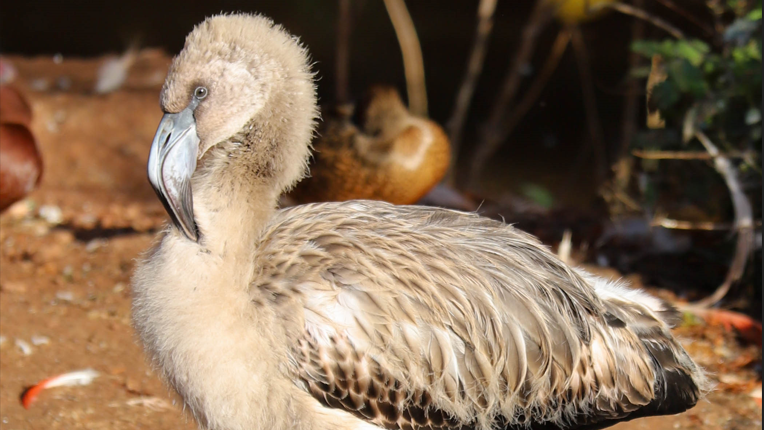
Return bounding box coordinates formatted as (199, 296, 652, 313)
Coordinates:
(0, 85, 42, 211)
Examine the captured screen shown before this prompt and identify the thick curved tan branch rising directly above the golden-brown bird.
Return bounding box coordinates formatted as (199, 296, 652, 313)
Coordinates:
(385, 0, 427, 117)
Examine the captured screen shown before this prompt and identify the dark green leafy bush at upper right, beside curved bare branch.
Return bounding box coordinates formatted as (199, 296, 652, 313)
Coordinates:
(631, 0, 762, 220)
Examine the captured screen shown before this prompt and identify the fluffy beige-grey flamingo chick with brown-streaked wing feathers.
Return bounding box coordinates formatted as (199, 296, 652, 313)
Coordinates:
(133, 14, 708, 430)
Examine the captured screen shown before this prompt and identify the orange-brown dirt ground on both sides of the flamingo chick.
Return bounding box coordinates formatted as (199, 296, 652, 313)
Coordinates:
(0, 51, 762, 430)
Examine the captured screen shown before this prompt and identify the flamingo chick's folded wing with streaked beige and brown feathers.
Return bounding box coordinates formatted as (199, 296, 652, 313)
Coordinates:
(253, 201, 676, 429)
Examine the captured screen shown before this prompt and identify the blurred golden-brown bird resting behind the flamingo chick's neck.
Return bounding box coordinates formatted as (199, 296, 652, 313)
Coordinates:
(289, 85, 450, 205)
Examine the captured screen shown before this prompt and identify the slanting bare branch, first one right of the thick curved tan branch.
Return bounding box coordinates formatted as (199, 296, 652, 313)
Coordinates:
(446, 0, 496, 181)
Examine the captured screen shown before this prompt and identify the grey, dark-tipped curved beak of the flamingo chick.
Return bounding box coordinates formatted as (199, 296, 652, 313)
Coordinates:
(148, 104, 199, 242)
